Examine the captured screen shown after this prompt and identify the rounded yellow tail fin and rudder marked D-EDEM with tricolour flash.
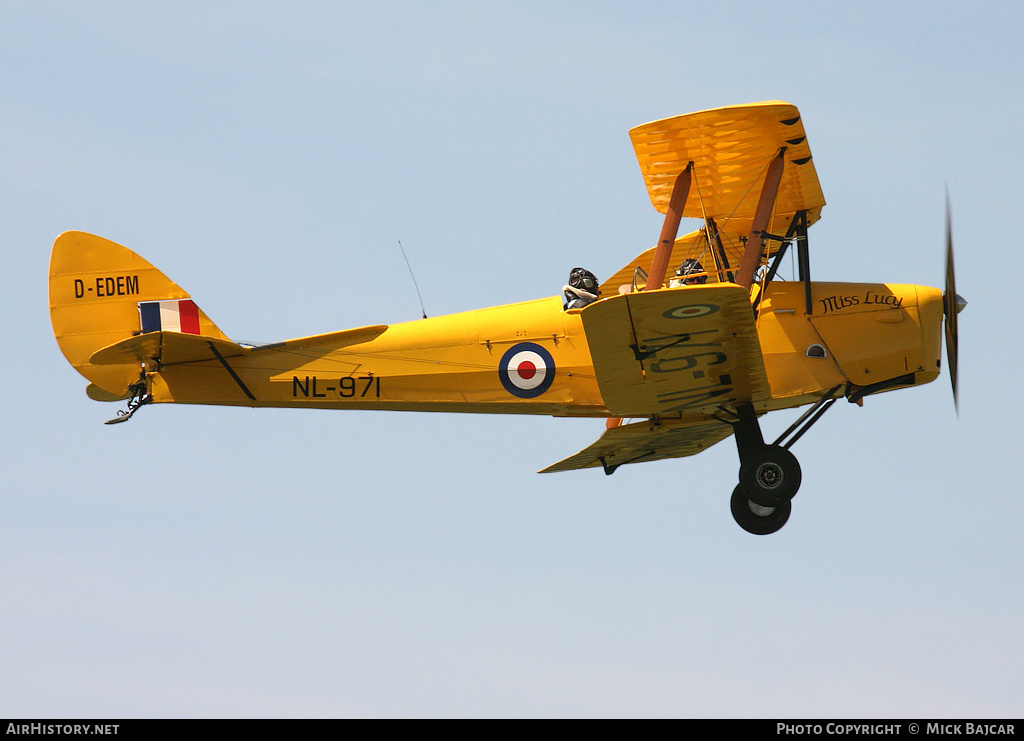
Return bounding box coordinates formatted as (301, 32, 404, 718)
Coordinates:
(49, 231, 227, 401)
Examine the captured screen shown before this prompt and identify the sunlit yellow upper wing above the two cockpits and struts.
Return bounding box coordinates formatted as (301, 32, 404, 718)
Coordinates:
(601, 100, 825, 296)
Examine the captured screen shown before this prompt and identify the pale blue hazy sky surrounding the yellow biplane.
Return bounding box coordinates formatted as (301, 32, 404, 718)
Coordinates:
(0, 2, 1024, 717)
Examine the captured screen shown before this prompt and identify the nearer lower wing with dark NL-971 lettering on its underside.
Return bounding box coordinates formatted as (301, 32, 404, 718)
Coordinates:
(582, 284, 771, 417)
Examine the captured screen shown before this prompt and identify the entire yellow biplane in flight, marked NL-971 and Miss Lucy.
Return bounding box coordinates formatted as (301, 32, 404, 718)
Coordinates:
(49, 101, 964, 534)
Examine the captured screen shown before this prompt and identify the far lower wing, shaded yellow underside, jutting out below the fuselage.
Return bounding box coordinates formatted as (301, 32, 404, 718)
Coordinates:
(541, 420, 732, 474)
